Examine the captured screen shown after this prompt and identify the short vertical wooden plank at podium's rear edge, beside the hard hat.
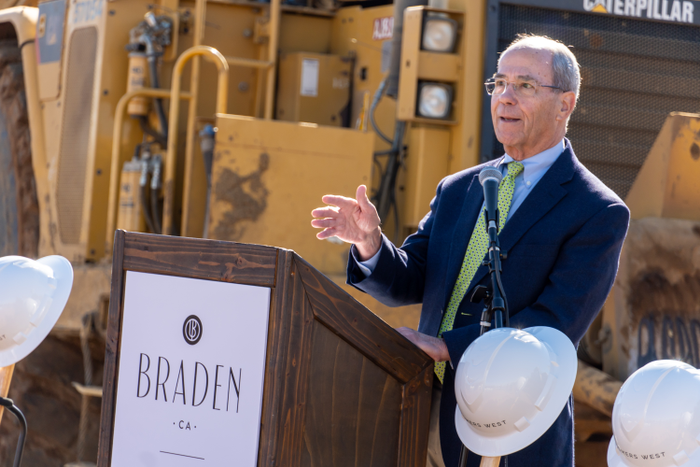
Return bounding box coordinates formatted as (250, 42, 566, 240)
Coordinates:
(398, 365, 433, 467)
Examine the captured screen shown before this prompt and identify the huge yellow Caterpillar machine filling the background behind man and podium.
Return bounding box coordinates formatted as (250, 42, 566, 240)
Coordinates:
(0, 0, 700, 467)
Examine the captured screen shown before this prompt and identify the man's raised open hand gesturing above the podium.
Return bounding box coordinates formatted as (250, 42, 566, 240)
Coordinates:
(311, 185, 382, 261)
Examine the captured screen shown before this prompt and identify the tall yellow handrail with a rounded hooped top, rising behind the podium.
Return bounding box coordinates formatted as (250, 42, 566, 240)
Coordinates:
(163, 45, 228, 235)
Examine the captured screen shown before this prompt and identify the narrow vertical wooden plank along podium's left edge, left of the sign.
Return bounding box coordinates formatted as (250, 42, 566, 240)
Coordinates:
(97, 230, 125, 467)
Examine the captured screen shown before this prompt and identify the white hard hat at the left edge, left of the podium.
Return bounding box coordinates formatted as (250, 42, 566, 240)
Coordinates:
(0, 256, 73, 367)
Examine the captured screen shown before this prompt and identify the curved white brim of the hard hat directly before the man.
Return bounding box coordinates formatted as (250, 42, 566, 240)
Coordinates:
(455, 326, 578, 457)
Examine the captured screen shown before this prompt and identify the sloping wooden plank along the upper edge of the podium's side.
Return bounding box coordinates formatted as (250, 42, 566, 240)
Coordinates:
(298, 258, 433, 384)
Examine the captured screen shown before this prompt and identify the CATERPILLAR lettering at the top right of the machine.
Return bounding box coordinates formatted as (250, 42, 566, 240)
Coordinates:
(583, 0, 695, 24)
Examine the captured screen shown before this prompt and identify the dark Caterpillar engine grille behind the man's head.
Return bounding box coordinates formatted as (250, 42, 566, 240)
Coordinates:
(484, 4, 700, 198)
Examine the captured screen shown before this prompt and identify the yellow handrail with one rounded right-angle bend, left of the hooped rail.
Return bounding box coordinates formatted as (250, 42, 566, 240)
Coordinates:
(105, 88, 191, 254)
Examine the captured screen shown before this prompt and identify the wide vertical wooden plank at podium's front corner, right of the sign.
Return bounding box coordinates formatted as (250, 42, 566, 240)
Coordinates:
(259, 256, 313, 467)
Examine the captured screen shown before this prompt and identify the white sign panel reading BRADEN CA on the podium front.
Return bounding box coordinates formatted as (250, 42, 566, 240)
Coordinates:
(111, 271, 270, 467)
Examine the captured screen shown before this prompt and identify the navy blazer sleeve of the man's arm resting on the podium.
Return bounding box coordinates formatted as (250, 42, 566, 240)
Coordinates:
(443, 203, 629, 367)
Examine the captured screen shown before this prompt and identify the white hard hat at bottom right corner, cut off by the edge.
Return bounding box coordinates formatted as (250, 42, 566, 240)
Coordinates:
(608, 360, 700, 467)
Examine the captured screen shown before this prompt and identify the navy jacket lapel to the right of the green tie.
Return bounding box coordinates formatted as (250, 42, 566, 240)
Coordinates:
(464, 144, 575, 297)
